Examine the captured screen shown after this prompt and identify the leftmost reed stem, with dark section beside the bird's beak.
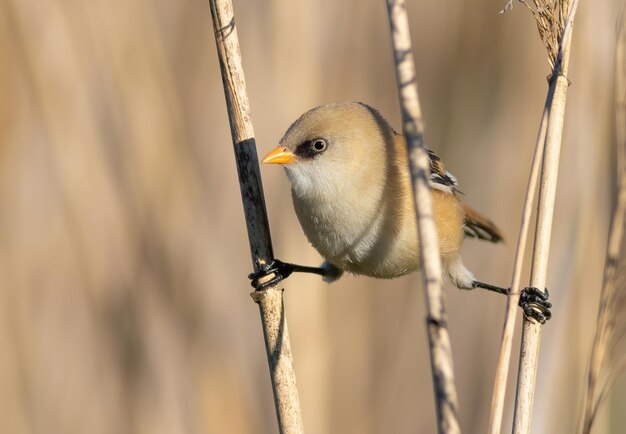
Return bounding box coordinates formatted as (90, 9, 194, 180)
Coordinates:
(209, 0, 303, 434)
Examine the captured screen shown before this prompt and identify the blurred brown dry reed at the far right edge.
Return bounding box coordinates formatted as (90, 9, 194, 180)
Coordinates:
(579, 11, 626, 434)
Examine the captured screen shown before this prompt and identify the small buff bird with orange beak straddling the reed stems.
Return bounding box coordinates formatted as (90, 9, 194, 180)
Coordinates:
(251, 102, 551, 322)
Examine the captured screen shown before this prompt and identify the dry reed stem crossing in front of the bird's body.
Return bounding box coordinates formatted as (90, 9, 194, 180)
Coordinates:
(380, 0, 461, 433)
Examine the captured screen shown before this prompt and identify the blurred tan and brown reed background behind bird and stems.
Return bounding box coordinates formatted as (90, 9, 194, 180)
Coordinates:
(0, 0, 626, 434)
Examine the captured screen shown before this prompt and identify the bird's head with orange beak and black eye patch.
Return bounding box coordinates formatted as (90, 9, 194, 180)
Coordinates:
(263, 102, 395, 197)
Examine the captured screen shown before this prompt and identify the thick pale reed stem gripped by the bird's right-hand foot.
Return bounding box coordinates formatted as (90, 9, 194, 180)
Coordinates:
(513, 0, 578, 434)
